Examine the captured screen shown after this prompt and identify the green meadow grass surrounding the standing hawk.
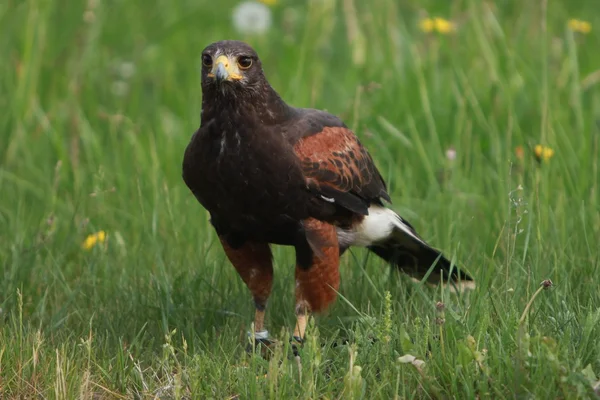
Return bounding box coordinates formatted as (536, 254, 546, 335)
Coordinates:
(0, 0, 600, 399)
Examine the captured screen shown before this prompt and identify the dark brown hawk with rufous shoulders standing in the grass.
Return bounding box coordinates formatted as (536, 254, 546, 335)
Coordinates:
(183, 40, 472, 343)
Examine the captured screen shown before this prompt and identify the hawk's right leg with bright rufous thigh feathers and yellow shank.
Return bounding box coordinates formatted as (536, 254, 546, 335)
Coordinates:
(292, 219, 340, 355)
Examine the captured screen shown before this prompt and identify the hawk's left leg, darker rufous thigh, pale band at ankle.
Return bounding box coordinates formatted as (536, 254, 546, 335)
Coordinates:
(220, 237, 273, 344)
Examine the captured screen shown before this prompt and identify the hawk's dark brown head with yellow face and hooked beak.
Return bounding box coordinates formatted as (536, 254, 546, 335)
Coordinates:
(202, 40, 265, 93)
